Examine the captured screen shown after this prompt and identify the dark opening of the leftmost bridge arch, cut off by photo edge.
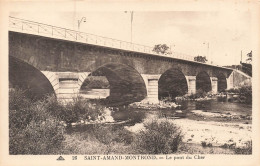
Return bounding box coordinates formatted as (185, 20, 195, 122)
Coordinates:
(9, 56, 55, 99)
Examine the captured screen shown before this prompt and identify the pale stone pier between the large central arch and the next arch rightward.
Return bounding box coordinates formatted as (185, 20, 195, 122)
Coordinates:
(141, 74, 161, 104)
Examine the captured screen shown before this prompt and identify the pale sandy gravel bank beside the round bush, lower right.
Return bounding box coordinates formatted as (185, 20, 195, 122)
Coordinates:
(125, 115, 252, 153)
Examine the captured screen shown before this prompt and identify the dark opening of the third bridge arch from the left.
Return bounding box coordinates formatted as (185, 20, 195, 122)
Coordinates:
(158, 68, 188, 99)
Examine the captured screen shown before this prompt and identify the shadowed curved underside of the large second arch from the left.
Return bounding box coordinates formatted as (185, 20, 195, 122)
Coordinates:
(80, 63, 147, 105)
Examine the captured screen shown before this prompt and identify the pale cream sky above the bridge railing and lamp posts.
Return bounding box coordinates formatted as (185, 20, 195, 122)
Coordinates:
(10, 10, 253, 66)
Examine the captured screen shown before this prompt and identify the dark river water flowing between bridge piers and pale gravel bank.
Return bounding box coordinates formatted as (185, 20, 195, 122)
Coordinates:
(112, 99, 252, 125)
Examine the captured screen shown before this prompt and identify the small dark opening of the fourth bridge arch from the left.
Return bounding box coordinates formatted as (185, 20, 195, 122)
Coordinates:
(196, 71, 212, 92)
